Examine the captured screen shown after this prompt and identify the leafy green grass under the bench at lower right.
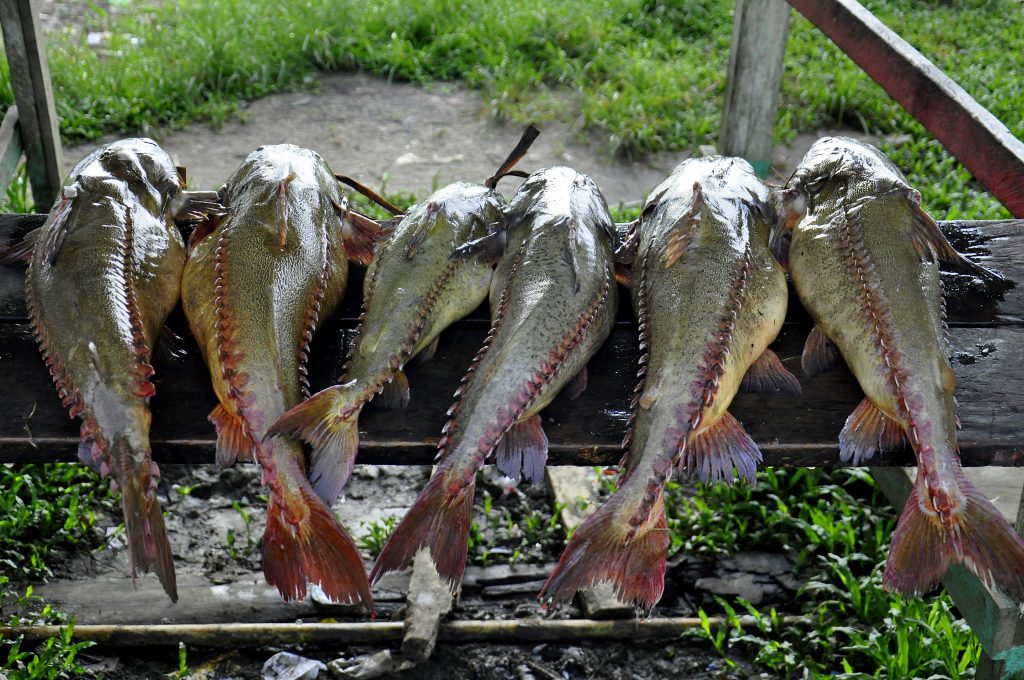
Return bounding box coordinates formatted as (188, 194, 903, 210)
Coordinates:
(666, 468, 981, 680)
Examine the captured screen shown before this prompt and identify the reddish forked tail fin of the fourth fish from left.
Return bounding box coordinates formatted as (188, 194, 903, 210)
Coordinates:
(370, 470, 476, 594)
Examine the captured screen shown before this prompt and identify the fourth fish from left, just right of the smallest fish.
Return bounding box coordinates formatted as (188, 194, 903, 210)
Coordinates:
(371, 167, 617, 593)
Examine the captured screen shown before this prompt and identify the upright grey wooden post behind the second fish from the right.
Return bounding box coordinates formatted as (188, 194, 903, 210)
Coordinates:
(718, 0, 790, 177)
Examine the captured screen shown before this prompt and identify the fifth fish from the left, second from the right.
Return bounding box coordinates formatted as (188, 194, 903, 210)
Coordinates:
(540, 157, 800, 615)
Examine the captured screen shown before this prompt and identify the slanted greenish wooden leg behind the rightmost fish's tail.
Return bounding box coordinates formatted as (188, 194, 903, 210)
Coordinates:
(872, 468, 1024, 657)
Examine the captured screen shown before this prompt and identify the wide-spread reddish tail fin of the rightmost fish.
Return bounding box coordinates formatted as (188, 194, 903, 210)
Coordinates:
(882, 470, 1024, 602)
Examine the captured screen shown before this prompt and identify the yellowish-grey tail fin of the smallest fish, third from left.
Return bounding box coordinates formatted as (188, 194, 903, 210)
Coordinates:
(263, 385, 368, 505)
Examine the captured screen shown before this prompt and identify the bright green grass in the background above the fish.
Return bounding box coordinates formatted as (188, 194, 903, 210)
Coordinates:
(0, 0, 1024, 223)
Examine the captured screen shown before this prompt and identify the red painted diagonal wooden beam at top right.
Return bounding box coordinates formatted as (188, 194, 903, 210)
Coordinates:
(787, 0, 1024, 217)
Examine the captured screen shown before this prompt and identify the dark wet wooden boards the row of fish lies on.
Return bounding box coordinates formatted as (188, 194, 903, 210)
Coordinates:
(0, 215, 1024, 466)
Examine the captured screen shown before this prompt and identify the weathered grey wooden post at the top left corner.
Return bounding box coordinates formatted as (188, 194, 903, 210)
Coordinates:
(0, 0, 63, 210)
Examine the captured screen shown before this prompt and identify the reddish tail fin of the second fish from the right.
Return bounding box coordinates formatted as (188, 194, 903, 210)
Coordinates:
(539, 485, 670, 613)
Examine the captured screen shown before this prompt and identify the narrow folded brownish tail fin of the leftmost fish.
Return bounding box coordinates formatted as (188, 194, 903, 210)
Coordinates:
(116, 458, 178, 602)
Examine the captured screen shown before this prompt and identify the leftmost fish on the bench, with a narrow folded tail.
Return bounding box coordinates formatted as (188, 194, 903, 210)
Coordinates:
(23, 138, 219, 601)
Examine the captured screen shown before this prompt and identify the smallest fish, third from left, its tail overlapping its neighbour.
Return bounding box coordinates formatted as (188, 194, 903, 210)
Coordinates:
(267, 126, 539, 502)
